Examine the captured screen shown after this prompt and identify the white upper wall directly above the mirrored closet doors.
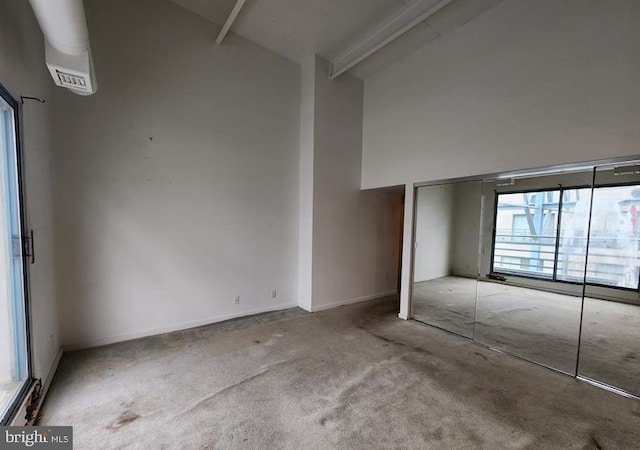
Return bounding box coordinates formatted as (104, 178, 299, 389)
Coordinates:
(362, 0, 640, 188)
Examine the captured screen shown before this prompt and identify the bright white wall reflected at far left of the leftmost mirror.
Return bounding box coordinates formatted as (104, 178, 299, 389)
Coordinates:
(413, 184, 454, 283)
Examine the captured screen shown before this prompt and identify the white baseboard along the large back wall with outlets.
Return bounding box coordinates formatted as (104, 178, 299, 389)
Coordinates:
(63, 303, 298, 352)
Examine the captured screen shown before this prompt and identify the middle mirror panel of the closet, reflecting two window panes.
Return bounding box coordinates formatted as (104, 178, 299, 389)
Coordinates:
(475, 171, 593, 374)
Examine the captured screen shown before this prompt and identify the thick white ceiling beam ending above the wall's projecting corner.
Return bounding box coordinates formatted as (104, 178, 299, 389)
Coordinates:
(329, 0, 453, 79)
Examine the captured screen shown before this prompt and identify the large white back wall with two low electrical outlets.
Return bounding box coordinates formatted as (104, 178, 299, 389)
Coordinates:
(54, 0, 300, 347)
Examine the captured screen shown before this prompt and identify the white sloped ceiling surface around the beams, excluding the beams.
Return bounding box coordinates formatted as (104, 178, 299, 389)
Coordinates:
(172, 0, 502, 78)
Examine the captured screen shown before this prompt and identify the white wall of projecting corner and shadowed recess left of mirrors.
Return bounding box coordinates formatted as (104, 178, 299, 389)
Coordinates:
(308, 58, 402, 310)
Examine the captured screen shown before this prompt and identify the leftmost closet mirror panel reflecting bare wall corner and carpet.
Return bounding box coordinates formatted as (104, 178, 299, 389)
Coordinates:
(411, 182, 482, 338)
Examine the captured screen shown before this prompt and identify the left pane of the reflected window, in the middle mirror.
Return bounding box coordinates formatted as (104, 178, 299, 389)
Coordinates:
(493, 191, 560, 278)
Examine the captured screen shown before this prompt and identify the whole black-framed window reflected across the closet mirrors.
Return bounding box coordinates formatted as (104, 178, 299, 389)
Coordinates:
(492, 185, 640, 289)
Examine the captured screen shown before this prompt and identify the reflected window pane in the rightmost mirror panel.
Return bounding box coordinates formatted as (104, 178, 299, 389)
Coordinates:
(587, 185, 640, 289)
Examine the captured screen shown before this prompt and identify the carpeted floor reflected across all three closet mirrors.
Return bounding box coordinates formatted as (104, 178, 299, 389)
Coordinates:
(412, 276, 640, 394)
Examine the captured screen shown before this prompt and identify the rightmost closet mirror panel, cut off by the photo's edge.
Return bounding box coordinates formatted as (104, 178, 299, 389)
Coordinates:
(578, 167, 640, 396)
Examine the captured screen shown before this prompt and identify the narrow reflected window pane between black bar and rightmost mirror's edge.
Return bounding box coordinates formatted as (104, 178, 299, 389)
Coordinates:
(556, 188, 591, 283)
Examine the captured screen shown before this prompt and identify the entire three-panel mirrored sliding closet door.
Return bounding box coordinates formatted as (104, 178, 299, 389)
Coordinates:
(412, 164, 640, 397)
